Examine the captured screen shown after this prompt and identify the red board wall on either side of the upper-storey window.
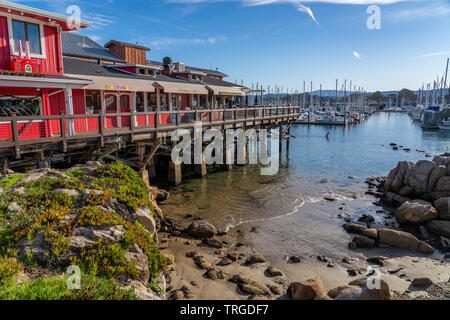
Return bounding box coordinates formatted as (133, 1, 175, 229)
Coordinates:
(0, 16, 63, 75)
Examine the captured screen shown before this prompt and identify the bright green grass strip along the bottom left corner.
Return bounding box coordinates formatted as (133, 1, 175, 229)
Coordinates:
(0, 276, 137, 300)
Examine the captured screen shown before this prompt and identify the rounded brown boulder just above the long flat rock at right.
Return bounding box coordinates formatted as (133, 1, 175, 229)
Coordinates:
(395, 200, 438, 224)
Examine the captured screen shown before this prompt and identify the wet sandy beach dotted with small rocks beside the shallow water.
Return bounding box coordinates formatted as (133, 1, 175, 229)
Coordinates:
(161, 199, 450, 300)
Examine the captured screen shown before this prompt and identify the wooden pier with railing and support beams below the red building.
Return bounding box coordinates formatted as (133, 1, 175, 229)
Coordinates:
(0, 106, 300, 184)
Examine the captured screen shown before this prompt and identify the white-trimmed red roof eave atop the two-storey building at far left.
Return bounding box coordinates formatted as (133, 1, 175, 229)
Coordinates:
(0, 0, 92, 31)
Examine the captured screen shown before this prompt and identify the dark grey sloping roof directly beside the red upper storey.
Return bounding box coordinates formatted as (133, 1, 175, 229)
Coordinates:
(61, 32, 125, 63)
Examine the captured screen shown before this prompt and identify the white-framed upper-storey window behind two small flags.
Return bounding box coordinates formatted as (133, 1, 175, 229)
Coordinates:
(12, 20, 42, 54)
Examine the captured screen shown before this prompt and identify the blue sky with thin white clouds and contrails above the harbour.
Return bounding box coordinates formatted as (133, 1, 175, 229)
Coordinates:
(15, 0, 450, 91)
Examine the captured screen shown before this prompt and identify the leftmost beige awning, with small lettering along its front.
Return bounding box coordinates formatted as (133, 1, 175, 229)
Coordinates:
(65, 75, 155, 92)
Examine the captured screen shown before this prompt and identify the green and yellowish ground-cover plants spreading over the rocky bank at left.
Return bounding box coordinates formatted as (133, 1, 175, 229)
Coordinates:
(0, 162, 166, 299)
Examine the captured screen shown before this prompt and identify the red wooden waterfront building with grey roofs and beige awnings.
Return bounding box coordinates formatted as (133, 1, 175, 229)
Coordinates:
(0, 1, 246, 146)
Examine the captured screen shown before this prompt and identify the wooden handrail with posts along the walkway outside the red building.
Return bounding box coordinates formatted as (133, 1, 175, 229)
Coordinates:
(0, 106, 301, 158)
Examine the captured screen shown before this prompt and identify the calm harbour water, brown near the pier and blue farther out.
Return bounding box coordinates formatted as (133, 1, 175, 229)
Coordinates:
(163, 113, 450, 250)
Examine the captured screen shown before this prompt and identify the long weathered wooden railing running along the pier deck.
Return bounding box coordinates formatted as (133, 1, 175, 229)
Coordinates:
(0, 106, 300, 158)
